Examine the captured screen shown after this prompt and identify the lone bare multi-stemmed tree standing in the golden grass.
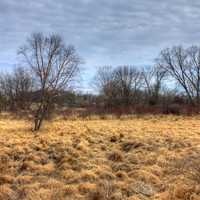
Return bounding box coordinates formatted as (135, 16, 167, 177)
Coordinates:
(19, 33, 80, 131)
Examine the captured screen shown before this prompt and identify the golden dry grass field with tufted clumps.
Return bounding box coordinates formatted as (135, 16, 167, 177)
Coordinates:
(0, 115, 200, 200)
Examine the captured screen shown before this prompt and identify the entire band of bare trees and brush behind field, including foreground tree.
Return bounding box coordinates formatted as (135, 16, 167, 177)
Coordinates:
(0, 33, 200, 130)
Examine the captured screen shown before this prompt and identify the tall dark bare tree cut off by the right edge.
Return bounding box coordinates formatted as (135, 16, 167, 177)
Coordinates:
(158, 46, 200, 105)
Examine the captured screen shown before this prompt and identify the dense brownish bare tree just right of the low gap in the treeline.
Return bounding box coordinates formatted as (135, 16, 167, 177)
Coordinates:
(95, 65, 142, 106)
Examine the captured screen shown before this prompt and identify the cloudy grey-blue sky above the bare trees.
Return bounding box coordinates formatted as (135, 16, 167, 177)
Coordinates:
(0, 0, 200, 92)
